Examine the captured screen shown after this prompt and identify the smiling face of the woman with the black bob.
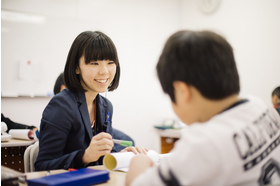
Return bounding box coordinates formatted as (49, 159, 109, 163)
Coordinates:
(76, 56, 116, 94)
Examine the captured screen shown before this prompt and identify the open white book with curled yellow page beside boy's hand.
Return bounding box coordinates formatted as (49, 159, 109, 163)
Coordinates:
(103, 150, 170, 172)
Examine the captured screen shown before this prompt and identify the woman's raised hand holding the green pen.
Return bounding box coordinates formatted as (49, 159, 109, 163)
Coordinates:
(83, 132, 114, 164)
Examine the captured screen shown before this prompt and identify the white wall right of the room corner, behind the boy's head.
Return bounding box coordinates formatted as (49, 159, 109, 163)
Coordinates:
(180, 0, 280, 104)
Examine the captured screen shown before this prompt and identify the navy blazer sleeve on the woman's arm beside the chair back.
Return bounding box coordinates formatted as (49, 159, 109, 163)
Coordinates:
(35, 95, 81, 171)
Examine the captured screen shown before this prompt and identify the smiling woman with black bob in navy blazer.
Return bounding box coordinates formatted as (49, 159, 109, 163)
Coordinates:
(35, 31, 147, 171)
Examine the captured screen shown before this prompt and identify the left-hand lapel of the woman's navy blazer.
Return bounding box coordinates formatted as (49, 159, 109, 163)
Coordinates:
(77, 92, 93, 139)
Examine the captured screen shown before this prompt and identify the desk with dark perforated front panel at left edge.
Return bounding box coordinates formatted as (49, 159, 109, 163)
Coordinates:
(1, 138, 34, 172)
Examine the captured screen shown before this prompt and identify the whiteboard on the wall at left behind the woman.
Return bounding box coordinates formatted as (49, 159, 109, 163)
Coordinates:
(1, 16, 98, 97)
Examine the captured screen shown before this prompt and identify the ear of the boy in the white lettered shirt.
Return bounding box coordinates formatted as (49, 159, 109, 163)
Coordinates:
(173, 81, 191, 103)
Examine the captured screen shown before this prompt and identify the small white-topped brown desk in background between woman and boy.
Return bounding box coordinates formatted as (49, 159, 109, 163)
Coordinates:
(156, 129, 181, 154)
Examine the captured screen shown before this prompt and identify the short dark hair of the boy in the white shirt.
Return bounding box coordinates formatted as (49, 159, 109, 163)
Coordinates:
(156, 30, 240, 103)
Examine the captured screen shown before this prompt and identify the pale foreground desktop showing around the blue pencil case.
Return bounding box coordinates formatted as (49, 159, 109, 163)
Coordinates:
(20, 165, 126, 186)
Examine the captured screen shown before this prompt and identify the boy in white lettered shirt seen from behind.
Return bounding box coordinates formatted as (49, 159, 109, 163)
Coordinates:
(126, 31, 280, 186)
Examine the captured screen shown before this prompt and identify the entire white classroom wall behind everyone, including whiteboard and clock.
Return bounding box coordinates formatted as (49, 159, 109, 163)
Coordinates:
(1, 0, 280, 152)
